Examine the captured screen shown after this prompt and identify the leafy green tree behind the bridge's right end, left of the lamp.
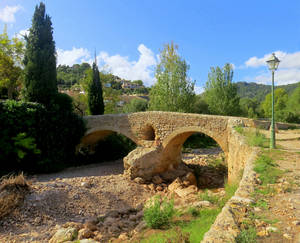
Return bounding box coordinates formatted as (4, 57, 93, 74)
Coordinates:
(204, 63, 240, 116)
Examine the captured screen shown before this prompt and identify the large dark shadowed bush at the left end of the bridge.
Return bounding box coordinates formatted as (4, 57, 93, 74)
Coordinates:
(0, 98, 85, 174)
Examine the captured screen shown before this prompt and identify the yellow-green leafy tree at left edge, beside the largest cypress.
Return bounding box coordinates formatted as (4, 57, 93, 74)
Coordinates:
(0, 28, 24, 99)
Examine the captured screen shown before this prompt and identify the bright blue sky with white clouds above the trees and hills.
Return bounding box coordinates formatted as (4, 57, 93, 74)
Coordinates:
(0, 0, 300, 91)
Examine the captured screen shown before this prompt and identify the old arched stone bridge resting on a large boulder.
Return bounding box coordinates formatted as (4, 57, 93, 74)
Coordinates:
(81, 111, 249, 181)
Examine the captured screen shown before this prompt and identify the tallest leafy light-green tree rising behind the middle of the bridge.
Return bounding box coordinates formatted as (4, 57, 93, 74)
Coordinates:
(149, 42, 195, 112)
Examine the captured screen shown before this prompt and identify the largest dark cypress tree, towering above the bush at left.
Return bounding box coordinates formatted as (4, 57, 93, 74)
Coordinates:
(24, 3, 57, 105)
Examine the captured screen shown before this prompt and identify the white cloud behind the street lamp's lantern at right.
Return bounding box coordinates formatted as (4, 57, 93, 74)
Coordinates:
(245, 51, 300, 85)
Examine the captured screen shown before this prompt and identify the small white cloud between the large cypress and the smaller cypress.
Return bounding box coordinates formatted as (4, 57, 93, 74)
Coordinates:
(57, 47, 91, 66)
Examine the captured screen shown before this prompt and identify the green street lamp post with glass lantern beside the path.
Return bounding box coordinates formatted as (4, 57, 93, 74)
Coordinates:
(267, 53, 280, 149)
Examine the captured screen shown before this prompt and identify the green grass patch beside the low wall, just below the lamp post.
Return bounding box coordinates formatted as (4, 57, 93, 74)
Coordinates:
(254, 154, 283, 185)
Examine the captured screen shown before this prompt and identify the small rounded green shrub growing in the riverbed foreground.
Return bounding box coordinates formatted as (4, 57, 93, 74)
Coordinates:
(144, 196, 175, 229)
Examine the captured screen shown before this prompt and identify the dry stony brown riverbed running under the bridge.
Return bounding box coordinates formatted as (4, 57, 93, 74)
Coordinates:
(0, 149, 224, 242)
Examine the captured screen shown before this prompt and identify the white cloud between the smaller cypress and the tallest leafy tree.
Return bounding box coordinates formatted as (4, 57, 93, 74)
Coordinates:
(97, 44, 157, 86)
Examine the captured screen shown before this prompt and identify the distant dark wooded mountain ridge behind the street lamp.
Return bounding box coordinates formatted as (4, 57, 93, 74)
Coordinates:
(236, 82, 300, 102)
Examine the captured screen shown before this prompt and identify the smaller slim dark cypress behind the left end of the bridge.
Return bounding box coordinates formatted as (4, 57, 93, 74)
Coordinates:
(88, 61, 104, 115)
